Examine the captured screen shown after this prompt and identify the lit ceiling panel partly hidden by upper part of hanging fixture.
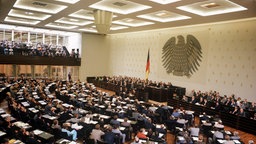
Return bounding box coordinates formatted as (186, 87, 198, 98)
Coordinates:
(68, 9, 117, 20)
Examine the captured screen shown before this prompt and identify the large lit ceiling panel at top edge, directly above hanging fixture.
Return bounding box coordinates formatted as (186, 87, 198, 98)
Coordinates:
(89, 0, 151, 14)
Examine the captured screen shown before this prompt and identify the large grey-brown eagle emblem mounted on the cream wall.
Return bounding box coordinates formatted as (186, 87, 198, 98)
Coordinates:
(162, 35, 202, 77)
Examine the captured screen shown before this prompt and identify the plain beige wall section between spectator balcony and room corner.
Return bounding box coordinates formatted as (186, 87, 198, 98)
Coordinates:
(79, 33, 109, 81)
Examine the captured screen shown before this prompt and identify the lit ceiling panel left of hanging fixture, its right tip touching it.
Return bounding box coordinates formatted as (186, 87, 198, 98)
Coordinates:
(55, 17, 93, 26)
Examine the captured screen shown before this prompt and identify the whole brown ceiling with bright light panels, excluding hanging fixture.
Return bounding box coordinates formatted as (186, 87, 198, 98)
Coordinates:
(0, 0, 256, 34)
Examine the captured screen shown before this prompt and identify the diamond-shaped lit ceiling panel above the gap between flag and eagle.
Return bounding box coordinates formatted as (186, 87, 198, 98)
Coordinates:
(137, 10, 191, 22)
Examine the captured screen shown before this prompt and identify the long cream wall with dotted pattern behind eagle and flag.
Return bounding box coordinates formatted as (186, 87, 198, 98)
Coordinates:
(107, 20, 256, 101)
